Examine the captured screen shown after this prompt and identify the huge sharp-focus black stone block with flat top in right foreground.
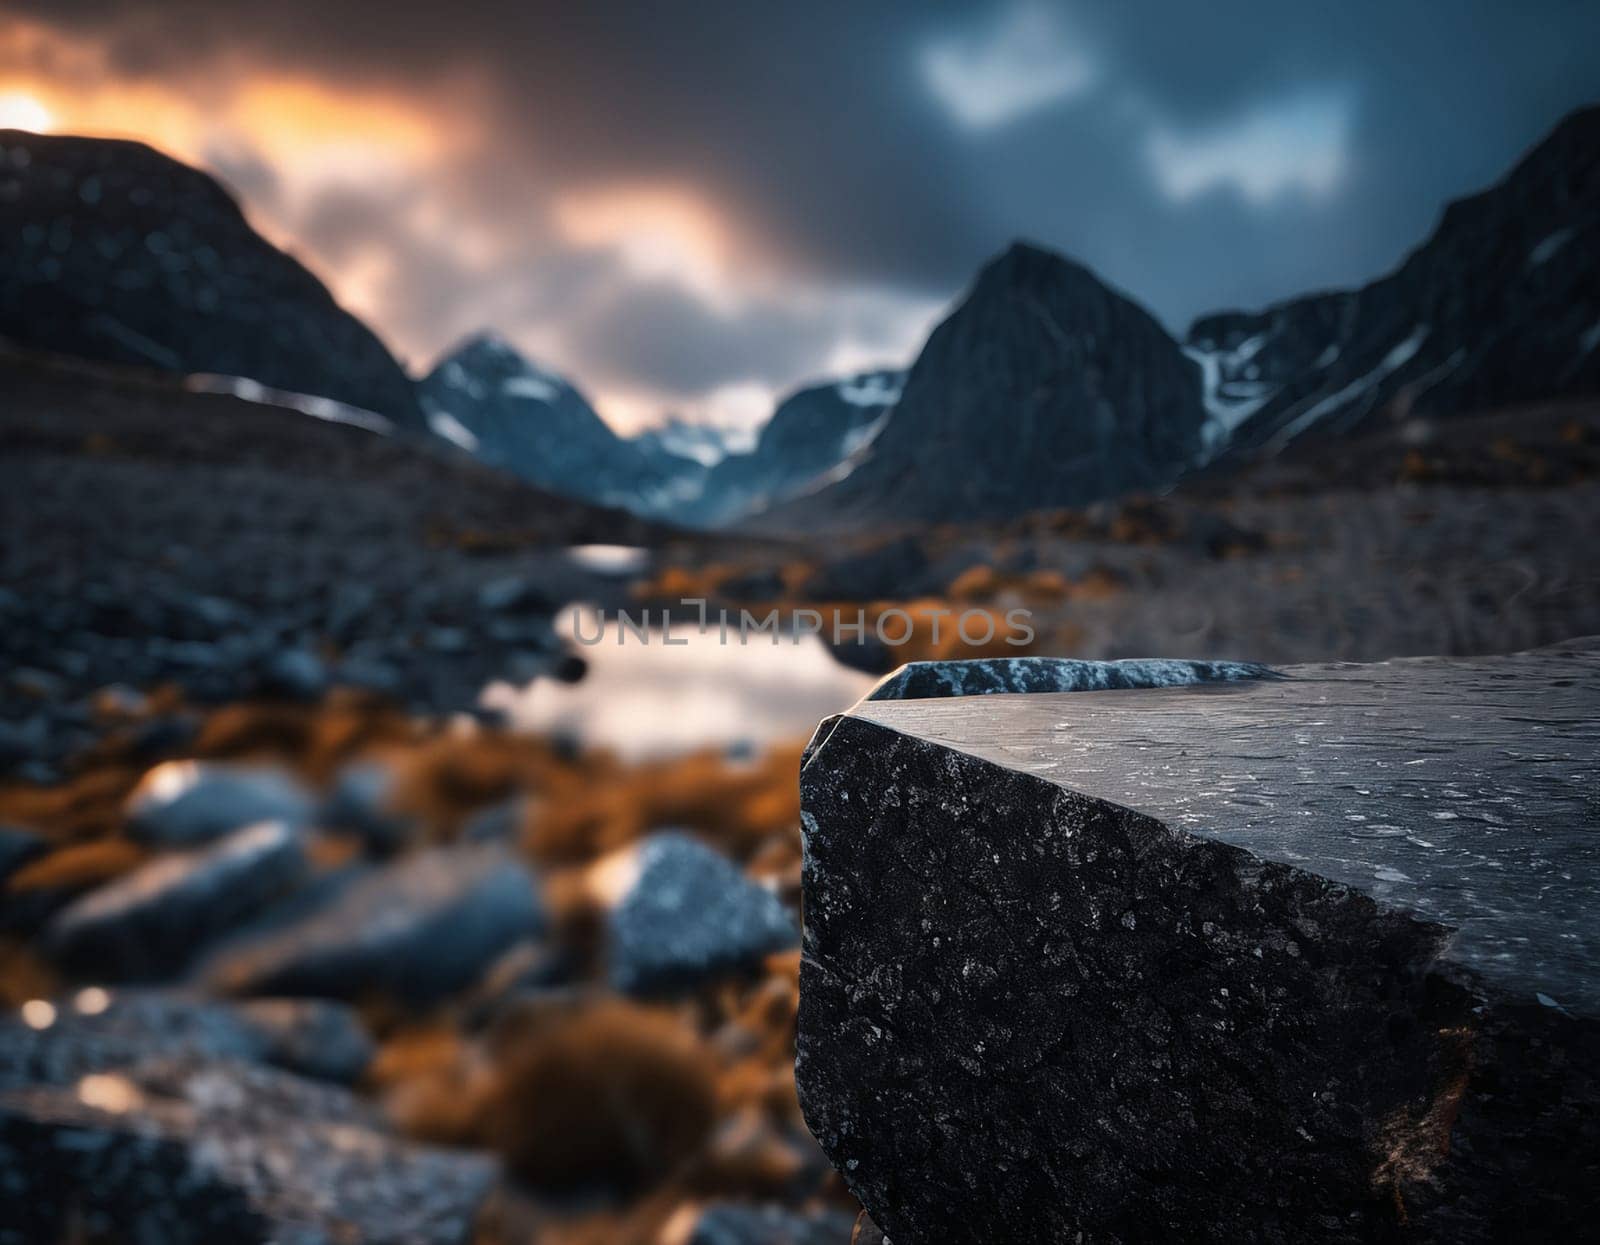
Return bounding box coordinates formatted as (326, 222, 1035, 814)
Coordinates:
(797, 650, 1600, 1245)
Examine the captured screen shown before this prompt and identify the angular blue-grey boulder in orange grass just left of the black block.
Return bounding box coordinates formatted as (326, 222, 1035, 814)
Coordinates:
(610, 832, 798, 994)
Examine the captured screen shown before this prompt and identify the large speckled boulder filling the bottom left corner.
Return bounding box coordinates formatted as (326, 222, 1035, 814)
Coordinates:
(0, 1059, 494, 1245)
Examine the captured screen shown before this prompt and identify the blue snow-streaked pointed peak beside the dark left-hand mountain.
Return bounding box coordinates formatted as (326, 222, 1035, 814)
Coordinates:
(419, 333, 704, 515)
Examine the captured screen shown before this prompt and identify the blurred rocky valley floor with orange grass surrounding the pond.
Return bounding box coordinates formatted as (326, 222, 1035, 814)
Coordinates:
(0, 344, 1600, 1245)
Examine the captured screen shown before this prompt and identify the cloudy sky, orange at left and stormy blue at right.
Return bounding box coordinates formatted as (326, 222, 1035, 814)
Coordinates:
(0, 0, 1600, 430)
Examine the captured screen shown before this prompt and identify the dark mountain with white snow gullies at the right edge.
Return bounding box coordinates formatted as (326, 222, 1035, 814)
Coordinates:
(1186, 107, 1600, 453)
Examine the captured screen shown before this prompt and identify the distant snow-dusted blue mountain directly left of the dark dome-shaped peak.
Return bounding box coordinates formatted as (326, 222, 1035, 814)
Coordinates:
(668, 371, 906, 526)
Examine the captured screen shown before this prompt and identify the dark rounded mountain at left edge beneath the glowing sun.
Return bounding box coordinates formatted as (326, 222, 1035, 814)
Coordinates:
(0, 130, 422, 429)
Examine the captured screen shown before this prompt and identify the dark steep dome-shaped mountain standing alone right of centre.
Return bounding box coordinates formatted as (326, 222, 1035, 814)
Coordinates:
(795, 243, 1205, 522)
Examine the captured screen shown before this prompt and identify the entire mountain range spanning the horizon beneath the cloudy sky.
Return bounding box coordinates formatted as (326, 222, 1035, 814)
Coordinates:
(0, 107, 1600, 528)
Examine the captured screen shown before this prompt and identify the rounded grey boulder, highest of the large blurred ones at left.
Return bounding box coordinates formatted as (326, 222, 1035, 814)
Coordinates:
(128, 760, 314, 847)
